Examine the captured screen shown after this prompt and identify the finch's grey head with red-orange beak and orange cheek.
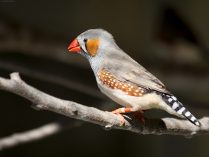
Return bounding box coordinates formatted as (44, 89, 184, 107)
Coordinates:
(68, 29, 119, 72)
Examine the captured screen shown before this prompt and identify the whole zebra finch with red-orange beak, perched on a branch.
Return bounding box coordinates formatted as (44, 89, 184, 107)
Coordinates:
(68, 28, 201, 127)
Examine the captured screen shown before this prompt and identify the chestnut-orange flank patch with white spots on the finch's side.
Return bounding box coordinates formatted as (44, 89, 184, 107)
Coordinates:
(99, 70, 145, 96)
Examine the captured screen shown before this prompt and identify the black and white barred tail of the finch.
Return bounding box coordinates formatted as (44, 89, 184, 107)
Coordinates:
(162, 94, 201, 126)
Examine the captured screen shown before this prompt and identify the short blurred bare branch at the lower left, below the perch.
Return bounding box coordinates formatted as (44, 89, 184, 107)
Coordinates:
(0, 121, 81, 150)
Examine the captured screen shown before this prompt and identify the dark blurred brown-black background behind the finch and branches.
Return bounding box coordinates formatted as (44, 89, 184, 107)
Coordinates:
(0, 0, 209, 157)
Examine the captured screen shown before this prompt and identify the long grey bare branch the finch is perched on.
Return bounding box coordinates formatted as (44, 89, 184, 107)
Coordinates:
(0, 73, 209, 136)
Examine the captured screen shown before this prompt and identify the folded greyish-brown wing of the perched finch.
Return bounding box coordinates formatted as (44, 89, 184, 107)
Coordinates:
(103, 49, 170, 94)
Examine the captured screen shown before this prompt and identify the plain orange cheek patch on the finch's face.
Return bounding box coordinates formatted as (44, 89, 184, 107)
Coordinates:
(86, 39, 99, 57)
